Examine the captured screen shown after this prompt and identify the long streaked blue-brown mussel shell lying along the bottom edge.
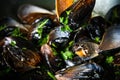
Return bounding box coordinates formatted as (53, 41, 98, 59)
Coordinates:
(55, 62, 103, 80)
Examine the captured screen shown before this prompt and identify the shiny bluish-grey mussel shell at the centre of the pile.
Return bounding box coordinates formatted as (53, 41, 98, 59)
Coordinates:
(49, 25, 70, 48)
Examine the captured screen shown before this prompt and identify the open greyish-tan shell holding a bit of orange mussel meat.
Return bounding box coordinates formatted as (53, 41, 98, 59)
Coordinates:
(73, 42, 99, 61)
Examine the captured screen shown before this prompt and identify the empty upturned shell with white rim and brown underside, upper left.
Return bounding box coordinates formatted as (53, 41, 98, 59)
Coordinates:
(18, 4, 56, 24)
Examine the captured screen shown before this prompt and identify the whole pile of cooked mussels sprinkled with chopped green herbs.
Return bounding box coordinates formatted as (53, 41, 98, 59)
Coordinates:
(0, 0, 120, 80)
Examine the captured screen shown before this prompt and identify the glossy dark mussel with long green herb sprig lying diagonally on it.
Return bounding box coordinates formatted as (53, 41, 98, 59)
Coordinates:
(29, 18, 55, 44)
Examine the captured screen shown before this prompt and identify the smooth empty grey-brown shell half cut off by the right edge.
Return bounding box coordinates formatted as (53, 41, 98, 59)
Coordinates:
(99, 24, 120, 50)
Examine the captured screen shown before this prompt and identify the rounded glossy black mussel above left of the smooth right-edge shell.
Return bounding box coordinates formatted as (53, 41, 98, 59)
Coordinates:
(85, 16, 107, 40)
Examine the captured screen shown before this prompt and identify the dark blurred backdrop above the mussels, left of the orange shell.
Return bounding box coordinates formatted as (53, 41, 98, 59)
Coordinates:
(0, 0, 55, 19)
